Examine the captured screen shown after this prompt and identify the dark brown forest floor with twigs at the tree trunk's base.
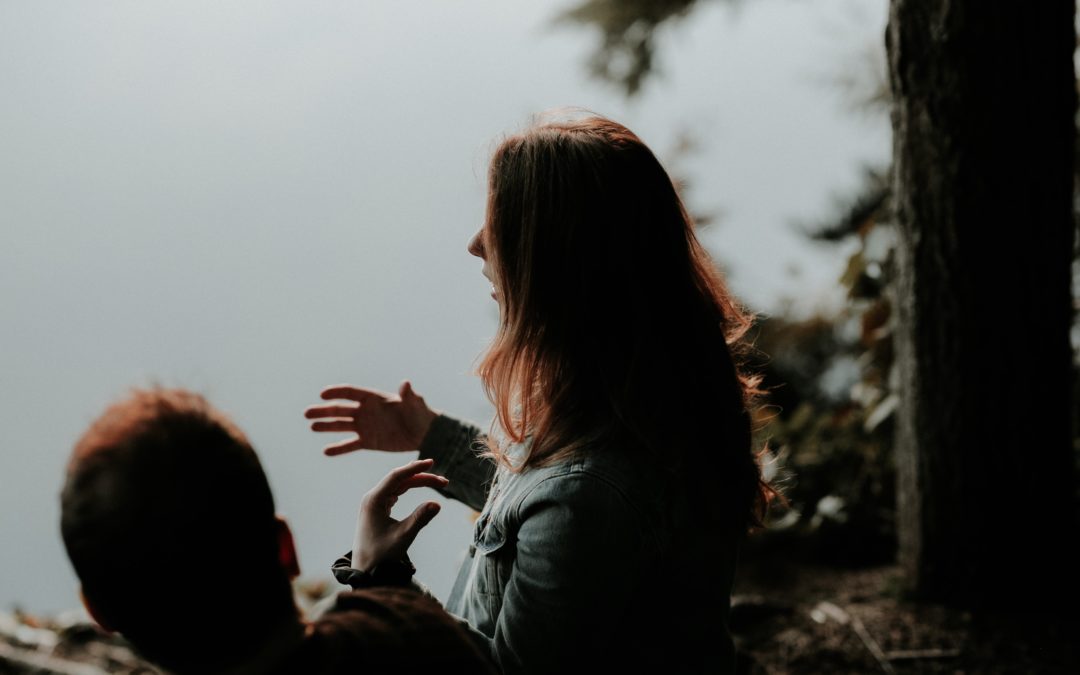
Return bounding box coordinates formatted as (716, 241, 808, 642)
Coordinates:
(731, 540, 1080, 675)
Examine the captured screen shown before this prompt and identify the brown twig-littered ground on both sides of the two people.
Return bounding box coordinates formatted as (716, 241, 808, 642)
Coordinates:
(0, 546, 1080, 675)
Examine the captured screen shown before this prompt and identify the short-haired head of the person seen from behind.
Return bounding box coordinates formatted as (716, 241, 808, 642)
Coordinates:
(60, 389, 296, 669)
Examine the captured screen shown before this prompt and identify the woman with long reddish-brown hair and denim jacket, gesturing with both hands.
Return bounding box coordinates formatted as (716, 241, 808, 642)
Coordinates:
(307, 117, 772, 673)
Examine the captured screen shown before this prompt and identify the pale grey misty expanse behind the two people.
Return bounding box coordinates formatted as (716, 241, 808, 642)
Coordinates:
(0, 0, 889, 610)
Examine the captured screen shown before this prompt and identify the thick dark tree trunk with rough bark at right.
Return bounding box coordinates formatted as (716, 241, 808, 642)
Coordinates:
(886, 0, 1080, 607)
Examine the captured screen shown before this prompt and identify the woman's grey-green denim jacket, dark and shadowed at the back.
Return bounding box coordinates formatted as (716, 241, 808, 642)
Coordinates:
(420, 416, 741, 673)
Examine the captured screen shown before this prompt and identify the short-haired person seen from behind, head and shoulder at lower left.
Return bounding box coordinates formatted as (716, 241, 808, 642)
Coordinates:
(60, 389, 494, 674)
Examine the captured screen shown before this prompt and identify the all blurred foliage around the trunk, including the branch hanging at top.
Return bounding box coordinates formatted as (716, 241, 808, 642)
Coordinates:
(557, 0, 1080, 566)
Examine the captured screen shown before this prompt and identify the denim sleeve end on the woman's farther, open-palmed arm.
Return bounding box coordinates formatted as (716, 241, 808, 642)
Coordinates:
(420, 415, 495, 511)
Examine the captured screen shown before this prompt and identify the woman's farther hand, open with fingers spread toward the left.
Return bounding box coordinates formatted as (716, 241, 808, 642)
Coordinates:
(303, 381, 438, 455)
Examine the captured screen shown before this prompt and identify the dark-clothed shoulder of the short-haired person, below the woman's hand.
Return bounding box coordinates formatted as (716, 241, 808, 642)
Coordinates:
(302, 586, 492, 673)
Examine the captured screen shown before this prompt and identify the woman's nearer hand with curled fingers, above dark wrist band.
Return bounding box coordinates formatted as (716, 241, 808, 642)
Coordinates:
(352, 459, 449, 571)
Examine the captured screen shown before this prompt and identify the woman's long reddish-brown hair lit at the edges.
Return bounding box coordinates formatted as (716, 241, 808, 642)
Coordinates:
(478, 117, 773, 525)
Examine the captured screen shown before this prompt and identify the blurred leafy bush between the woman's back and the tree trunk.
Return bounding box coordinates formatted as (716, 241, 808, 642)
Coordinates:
(755, 166, 899, 565)
